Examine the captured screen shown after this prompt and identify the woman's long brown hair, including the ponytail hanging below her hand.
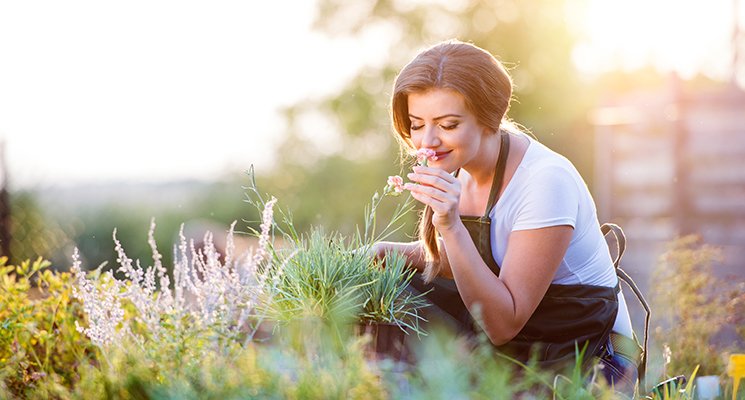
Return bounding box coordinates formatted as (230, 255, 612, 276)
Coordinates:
(391, 40, 512, 282)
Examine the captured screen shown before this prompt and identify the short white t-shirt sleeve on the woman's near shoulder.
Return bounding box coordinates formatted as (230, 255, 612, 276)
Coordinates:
(512, 165, 579, 231)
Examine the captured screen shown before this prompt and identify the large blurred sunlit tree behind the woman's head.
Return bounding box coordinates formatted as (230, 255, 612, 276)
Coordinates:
(264, 0, 593, 234)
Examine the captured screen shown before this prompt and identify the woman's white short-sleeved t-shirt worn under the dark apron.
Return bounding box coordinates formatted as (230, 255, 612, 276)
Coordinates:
(489, 134, 632, 337)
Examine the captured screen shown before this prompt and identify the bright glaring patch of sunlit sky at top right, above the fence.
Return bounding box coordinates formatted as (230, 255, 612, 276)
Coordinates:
(574, 0, 734, 79)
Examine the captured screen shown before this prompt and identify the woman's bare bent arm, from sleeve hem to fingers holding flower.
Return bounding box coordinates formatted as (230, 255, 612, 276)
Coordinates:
(405, 167, 574, 345)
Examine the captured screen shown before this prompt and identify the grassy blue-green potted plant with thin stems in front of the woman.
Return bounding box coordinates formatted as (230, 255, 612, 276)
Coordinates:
(247, 168, 427, 360)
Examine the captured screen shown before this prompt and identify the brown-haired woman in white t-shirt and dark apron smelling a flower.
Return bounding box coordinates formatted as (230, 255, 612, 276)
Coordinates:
(374, 41, 638, 393)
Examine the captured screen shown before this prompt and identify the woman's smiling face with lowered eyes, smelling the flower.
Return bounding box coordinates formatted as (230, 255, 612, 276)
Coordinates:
(408, 89, 486, 172)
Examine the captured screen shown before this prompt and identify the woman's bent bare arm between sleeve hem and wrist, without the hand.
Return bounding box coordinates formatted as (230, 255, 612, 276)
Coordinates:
(441, 224, 573, 345)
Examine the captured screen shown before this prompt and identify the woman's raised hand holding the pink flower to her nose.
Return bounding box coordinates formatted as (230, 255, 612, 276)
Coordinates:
(404, 166, 461, 232)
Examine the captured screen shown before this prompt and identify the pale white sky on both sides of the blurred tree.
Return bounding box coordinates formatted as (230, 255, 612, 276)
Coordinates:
(0, 0, 745, 188)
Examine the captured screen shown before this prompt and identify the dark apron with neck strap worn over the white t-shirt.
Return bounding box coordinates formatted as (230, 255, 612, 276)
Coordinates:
(412, 133, 619, 367)
